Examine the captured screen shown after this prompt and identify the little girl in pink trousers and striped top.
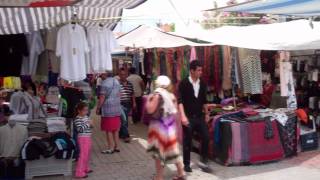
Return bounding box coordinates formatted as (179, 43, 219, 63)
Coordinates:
(74, 102, 92, 178)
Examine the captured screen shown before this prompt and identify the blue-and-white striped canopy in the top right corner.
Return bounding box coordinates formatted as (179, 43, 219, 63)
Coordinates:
(209, 0, 320, 16)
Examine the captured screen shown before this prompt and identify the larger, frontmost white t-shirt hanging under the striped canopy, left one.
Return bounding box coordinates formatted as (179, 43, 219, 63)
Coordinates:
(56, 24, 89, 81)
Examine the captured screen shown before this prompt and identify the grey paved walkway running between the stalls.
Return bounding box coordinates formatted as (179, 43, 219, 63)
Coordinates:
(36, 115, 320, 180)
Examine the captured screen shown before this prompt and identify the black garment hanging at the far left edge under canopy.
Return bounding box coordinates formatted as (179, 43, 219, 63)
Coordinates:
(0, 34, 28, 77)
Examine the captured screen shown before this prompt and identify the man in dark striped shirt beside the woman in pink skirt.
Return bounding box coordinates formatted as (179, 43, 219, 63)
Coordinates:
(119, 68, 136, 143)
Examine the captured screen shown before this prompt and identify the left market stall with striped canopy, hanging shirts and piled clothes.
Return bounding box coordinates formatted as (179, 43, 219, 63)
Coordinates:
(0, 0, 148, 179)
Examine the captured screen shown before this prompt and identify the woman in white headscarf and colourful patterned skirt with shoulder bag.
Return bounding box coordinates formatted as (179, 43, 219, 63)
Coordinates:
(145, 76, 185, 180)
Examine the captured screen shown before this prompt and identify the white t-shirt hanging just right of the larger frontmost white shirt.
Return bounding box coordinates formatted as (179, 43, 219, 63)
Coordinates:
(88, 26, 118, 73)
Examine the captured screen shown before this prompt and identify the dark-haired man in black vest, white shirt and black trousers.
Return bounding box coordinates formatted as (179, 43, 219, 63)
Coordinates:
(179, 60, 212, 172)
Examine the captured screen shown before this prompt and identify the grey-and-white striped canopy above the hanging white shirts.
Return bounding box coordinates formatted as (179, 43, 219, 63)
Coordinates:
(0, 0, 146, 34)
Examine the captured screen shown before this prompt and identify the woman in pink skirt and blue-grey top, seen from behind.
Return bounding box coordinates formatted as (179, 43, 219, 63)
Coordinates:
(97, 73, 121, 154)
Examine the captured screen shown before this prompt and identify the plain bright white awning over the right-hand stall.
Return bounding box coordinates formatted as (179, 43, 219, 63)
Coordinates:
(197, 20, 320, 50)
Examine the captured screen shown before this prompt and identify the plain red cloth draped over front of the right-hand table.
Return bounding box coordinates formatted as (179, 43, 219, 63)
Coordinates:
(248, 121, 284, 163)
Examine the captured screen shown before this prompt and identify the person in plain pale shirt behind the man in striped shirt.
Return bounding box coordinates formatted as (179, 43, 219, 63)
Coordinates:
(127, 68, 145, 123)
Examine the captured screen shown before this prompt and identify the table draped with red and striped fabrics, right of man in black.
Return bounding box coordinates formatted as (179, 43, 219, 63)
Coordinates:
(194, 108, 298, 166)
